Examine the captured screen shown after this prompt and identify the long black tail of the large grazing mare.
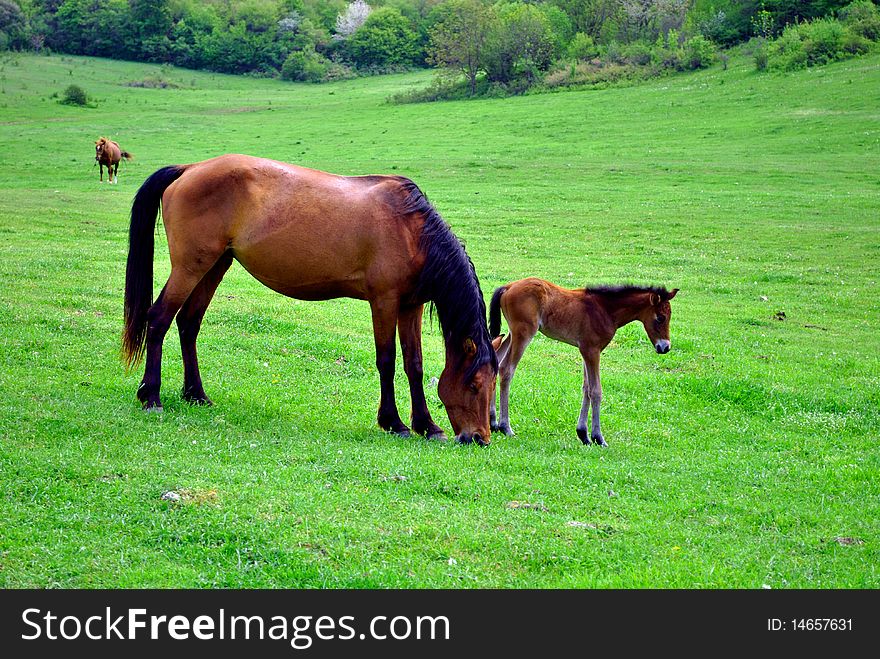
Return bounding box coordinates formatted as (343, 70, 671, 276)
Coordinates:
(122, 165, 186, 369)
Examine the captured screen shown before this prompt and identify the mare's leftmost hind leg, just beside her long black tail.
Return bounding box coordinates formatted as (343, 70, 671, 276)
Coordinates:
(137, 265, 213, 412)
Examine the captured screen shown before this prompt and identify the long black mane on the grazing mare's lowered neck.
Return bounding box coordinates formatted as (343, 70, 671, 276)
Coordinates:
(400, 178, 498, 380)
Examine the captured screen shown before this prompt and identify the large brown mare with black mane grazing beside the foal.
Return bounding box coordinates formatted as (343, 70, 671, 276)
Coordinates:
(123, 155, 498, 445)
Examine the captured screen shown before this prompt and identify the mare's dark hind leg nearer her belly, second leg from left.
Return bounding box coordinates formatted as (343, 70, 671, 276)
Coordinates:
(177, 252, 232, 405)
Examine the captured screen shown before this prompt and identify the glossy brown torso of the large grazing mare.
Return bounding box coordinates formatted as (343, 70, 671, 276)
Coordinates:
(163, 155, 428, 299)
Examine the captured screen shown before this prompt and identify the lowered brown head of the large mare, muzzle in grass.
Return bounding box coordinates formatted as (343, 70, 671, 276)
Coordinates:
(437, 337, 498, 446)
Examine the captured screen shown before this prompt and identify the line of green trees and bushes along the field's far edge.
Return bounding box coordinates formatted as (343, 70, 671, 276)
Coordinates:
(0, 0, 871, 95)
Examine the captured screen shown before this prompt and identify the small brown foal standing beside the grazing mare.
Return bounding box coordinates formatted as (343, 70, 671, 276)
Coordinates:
(489, 277, 678, 446)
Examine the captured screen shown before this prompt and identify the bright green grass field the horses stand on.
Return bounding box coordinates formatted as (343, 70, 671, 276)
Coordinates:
(0, 55, 880, 588)
